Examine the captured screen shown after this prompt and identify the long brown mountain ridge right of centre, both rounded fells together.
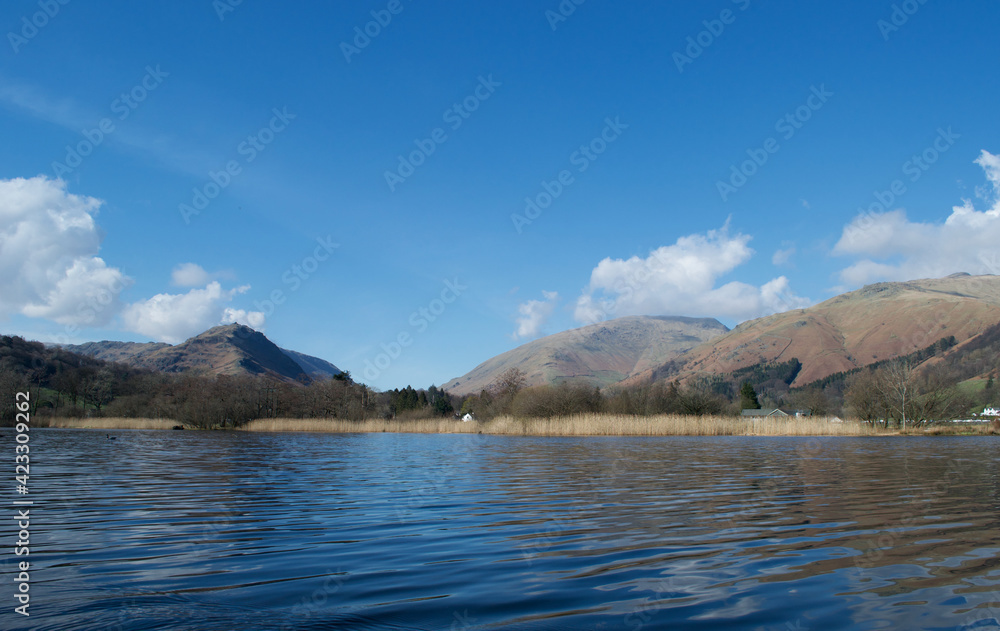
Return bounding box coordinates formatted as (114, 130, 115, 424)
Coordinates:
(443, 273, 1000, 394)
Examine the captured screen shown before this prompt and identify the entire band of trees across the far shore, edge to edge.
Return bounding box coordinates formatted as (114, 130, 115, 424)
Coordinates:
(0, 325, 1000, 427)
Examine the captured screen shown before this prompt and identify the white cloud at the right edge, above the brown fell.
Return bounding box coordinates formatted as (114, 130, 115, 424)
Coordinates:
(833, 151, 1000, 286)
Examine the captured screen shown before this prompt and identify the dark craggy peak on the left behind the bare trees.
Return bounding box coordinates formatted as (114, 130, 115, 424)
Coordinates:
(64, 324, 342, 381)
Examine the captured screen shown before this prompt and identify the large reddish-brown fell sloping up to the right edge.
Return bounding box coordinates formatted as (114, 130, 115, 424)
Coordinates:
(627, 274, 1000, 387)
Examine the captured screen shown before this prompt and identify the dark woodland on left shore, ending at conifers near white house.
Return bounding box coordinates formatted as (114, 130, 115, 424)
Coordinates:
(0, 336, 453, 428)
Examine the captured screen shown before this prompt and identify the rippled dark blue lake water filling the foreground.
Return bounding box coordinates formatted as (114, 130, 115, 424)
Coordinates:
(0, 430, 1000, 631)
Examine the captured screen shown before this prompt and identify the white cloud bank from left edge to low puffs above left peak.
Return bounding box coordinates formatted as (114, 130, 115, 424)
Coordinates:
(0, 176, 264, 343)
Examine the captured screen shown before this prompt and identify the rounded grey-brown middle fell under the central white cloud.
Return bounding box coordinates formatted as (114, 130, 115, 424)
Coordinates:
(442, 316, 729, 395)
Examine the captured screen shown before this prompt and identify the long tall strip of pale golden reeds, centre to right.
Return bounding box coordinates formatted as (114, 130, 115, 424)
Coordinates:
(242, 414, 884, 436)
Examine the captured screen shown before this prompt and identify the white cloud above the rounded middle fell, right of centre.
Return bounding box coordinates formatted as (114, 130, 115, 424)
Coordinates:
(575, 222, 811, 324)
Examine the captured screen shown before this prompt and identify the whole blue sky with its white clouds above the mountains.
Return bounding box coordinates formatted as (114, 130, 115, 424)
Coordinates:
(0, 0, 1000, 389)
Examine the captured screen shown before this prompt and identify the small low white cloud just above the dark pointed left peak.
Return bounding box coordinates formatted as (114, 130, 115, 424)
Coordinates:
(122, 281, 263, 344)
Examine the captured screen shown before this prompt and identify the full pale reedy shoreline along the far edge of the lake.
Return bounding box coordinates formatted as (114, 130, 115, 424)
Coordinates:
(37, 414, 1000, 437)
